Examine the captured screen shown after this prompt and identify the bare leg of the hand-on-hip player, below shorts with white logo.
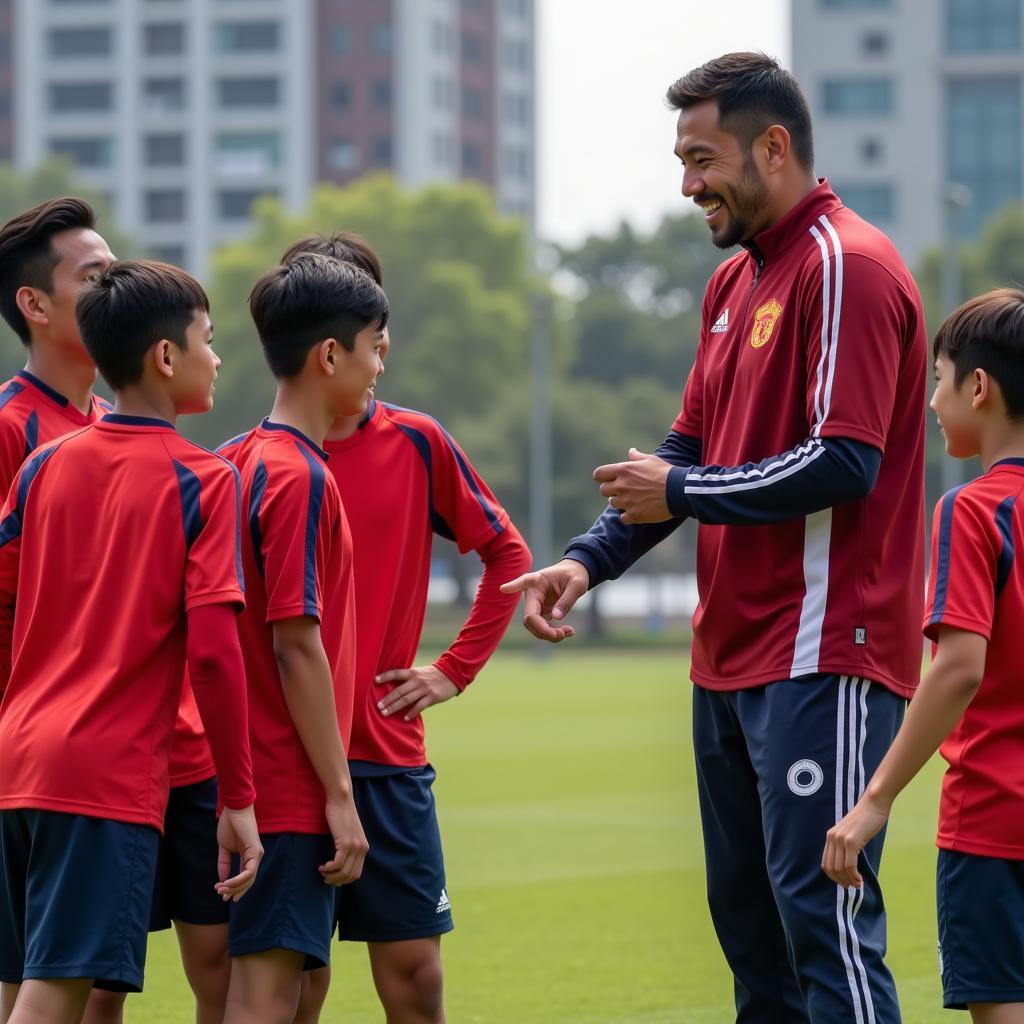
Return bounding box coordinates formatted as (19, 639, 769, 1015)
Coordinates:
(367, 935, 444, 1024)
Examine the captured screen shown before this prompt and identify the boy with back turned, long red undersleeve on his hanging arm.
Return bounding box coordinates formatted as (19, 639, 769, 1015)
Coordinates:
(0, 261, 262, 1024)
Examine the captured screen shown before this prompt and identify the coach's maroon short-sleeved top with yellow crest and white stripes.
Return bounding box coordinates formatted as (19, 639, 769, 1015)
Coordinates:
(673, 181, 928, 696)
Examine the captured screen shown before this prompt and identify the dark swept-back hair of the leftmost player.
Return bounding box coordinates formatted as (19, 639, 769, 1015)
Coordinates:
(0, 196, 96, 345)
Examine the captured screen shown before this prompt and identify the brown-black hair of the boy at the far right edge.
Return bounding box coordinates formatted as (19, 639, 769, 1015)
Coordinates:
(932, 288, 1024, 420)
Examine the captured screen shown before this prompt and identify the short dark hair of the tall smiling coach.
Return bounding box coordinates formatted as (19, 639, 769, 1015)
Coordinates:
(665, 52, 814, 171)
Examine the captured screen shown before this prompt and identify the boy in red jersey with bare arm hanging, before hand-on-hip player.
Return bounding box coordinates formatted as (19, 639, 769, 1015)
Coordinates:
(220, 254, 388, 1024)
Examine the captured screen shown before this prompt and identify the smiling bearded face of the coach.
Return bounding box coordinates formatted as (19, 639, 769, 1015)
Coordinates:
(675, 99, 788, 249)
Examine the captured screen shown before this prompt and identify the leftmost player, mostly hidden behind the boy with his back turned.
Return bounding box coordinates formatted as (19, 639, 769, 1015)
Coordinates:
(0, 197, 238, 1024)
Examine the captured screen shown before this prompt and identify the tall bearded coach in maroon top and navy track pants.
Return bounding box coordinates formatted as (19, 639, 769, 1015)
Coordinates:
(510, 53, 928, 1024)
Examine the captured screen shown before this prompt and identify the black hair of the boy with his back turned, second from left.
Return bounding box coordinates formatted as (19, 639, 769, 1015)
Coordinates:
(75, 259, 210, 391)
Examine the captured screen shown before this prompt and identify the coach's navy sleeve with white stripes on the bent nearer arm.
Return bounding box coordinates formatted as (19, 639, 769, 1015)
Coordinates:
(663, 437, 882, 525)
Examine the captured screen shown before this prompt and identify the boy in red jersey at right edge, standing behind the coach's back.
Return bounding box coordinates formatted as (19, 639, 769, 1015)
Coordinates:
(821, 288, 1024, 1024)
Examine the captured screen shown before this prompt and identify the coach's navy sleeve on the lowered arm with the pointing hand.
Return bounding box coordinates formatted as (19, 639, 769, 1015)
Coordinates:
(565, 430, 700, 588)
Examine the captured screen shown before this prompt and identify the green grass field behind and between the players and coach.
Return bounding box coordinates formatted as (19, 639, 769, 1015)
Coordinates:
(136, 645, 945, 1024)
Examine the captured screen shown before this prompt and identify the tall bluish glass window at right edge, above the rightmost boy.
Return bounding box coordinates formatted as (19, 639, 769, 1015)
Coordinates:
(945, 76, 1024, 239)
